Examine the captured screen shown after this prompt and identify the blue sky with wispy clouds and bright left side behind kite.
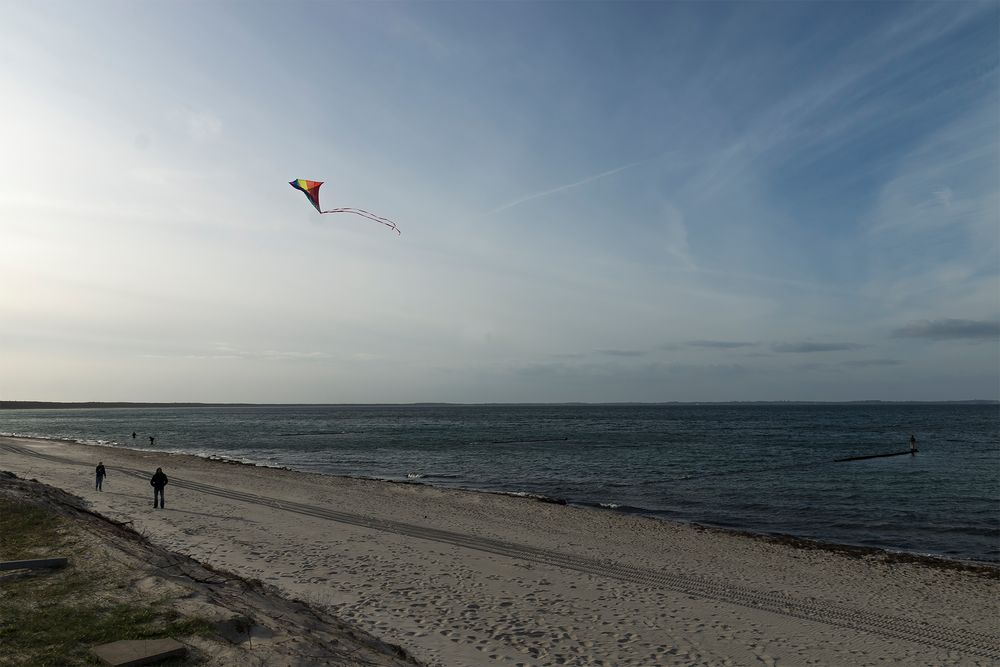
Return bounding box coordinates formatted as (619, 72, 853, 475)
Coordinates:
(0, 0, 1000, 403)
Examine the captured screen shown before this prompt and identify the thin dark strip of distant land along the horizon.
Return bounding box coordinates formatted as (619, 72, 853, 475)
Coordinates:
(0, 399, 1000, 410)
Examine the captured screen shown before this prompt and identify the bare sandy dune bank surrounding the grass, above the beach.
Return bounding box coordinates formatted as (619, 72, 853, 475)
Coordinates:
(0, 472, 417, 667)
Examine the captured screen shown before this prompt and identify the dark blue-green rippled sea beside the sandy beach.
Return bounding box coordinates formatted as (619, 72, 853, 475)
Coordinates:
(0, 403, 1000, 564)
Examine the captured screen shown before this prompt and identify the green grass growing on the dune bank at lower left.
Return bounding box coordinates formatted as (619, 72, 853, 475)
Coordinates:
(0, 498, 215, 667)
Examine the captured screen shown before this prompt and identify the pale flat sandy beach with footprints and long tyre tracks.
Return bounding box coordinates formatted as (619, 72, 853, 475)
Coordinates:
(0, 437, 1000, 666)
